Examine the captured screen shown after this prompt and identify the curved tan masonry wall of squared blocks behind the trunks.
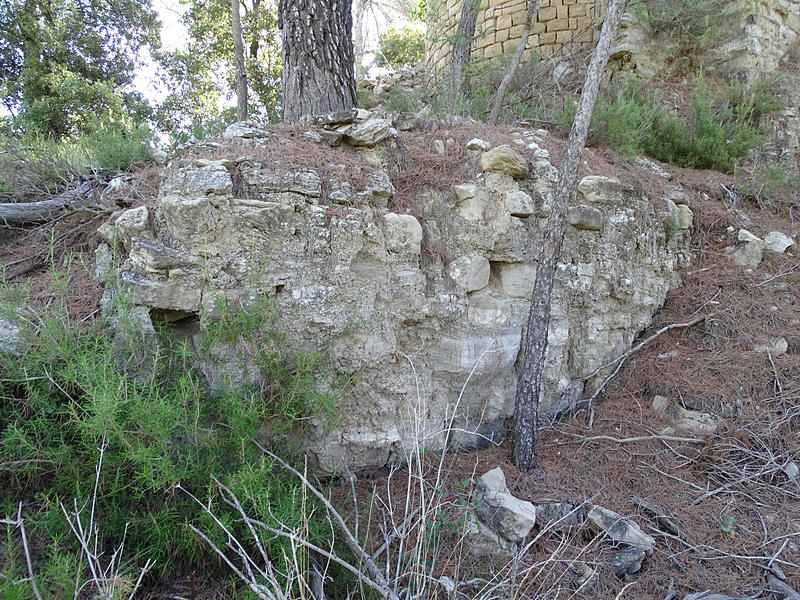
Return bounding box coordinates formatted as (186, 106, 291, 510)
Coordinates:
(428, 0, 607, 71)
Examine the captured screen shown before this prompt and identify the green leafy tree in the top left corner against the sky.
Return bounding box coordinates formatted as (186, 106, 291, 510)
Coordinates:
(0, 0, 159, 139)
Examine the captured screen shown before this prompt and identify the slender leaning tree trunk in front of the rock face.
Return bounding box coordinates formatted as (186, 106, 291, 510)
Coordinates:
(512, 0, 627, 471)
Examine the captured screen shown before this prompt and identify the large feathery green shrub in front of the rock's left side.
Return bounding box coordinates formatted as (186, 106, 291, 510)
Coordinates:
(0, 278, 342, 598)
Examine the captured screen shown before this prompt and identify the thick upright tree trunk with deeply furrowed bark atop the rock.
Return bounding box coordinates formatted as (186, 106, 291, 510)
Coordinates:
(278, 0, 356, 123)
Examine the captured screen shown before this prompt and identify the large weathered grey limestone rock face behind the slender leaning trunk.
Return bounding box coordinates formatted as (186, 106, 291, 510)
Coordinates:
(103, 130, 688, 473)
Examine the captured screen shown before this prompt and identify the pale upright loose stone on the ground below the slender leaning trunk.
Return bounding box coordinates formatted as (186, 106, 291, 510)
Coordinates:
(475, 467, 536, 543)
